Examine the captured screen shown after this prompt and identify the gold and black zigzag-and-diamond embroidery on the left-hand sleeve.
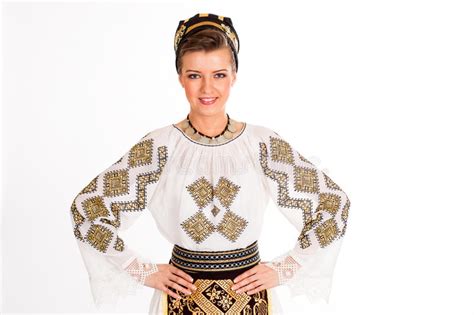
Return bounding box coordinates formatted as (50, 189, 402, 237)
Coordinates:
(70, 134, 168, 253)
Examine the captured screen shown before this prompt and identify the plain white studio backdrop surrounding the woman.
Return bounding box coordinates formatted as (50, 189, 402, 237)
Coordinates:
(1, 0, 474, 315)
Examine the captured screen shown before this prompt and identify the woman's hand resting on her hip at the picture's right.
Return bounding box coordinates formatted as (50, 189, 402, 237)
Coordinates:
(231, 263, 278, 295)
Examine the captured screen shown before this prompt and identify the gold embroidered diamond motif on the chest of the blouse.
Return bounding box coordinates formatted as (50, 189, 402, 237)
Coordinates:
(181, 176, 248, 244)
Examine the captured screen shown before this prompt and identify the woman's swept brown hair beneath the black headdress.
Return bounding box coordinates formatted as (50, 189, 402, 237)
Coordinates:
(177, 28, 236, 73)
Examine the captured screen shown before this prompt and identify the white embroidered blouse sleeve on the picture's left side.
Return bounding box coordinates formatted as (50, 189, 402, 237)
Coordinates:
(70, 132, 168, 307)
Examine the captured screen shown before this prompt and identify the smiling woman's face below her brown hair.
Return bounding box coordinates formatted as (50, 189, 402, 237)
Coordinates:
(179, 47, 236, 116)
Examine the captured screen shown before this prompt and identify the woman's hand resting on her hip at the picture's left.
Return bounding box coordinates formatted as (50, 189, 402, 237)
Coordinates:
(145, 264, 197, 299)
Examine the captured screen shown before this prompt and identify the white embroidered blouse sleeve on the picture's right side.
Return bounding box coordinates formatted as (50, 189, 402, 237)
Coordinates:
(259, 131, 350, 303)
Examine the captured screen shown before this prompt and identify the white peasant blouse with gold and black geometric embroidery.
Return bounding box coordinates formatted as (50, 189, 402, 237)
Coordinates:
(71, 123, 350, 314)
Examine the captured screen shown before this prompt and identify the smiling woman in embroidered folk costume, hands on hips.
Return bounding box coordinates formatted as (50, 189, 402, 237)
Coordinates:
(71, 14, 350, 314)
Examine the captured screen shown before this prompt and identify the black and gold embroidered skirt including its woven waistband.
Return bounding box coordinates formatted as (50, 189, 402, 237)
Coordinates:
(162, 241, 270, 315)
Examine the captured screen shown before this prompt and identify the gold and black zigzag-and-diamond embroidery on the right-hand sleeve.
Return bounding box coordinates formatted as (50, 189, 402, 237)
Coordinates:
(259, 133, 350, 249)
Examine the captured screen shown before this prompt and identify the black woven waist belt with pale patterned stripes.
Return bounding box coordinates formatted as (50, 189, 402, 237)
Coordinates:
(171, 241, 260, 272)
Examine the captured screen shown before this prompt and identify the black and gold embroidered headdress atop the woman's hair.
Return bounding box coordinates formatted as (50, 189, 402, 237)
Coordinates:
(174, 13, 240, 71)
